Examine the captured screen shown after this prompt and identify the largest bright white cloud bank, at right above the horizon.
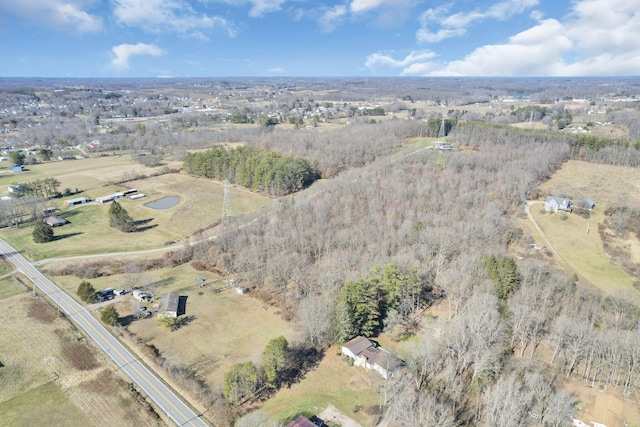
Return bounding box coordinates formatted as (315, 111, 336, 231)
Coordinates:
(429, 0, 640, 76)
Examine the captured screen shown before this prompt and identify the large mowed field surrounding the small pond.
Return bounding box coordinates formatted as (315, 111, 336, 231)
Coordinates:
(1, 174, 271, 260)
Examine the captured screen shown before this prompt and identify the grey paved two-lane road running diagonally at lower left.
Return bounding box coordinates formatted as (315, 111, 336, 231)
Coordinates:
(0, 239, 208, 427)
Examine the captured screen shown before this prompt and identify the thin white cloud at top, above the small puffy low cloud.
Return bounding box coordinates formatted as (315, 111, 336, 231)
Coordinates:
(114, 0, 235, 39)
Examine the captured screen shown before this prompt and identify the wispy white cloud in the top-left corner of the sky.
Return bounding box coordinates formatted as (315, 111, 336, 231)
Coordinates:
(0, 0, 102, 33)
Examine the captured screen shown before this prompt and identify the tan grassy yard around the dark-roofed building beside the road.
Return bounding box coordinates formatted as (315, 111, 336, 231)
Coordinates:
(48, 265, 293, 396)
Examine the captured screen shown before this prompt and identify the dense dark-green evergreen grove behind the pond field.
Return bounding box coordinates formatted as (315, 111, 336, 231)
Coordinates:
(184, 146, 318, 196)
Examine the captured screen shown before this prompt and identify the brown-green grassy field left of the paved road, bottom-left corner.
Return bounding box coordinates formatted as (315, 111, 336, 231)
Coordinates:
(0, 293, 162, 427)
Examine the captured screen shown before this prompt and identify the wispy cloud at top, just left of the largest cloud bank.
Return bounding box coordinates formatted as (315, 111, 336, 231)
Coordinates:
(416, 0, 538, 43)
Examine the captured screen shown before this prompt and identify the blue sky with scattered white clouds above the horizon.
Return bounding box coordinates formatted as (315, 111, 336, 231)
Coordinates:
(0, 0, 640, 77)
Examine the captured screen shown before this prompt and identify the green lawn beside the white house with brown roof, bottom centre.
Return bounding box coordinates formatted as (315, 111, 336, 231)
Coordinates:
(262, 346, 382, 426)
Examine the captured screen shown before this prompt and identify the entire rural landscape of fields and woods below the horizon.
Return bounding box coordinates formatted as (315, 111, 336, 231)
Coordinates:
(0, 77, 640, 427)
